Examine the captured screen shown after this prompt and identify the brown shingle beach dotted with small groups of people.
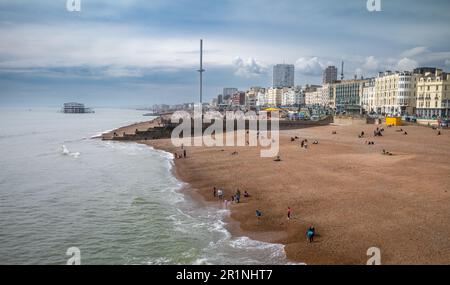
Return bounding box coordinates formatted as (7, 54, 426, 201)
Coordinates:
(132, 122, 450, 264)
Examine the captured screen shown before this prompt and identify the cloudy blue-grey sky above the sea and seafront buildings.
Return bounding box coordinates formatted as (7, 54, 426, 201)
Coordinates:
(0, 0, 450, 108)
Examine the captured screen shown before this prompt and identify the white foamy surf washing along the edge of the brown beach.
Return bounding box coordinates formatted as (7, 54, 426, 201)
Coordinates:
(101, 142, 289, 265)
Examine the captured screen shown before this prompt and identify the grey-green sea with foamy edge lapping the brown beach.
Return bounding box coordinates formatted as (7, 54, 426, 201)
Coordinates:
(0, 108, 288, 265)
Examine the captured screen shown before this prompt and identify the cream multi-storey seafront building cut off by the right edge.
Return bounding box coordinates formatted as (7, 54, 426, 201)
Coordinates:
(416, 69, 450, 118)
